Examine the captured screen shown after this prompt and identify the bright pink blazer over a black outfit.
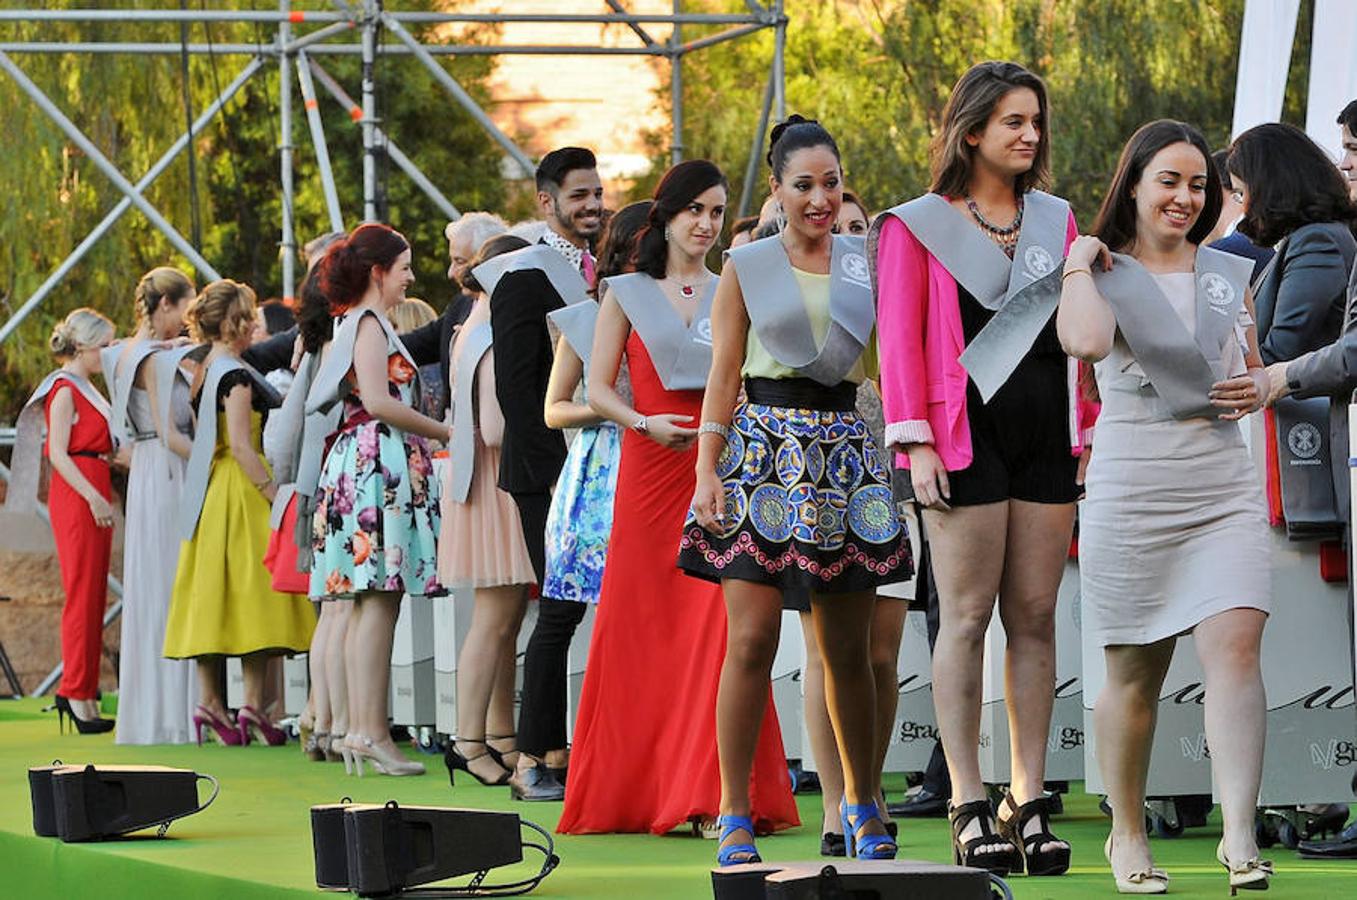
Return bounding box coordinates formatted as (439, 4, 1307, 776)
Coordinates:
(877, 204, 1098, 472)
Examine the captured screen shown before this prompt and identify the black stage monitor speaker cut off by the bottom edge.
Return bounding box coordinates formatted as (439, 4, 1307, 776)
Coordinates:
(711, 859, 995, 900)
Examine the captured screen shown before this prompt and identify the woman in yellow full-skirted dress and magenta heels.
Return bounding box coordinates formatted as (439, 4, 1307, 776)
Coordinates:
(164, 280, 316, 745)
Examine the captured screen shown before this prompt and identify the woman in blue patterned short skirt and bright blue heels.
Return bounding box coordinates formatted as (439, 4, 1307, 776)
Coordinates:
(679, 115, 911, 866)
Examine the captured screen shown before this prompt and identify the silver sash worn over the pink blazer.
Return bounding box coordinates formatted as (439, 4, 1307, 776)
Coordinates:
(871, 190, 1069, 402)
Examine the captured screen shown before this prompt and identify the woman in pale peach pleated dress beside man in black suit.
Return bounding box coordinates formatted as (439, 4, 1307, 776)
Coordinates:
(438, 235, 537, 785)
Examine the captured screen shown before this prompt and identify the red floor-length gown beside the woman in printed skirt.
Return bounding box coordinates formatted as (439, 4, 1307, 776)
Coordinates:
(556, 333, 801, 835)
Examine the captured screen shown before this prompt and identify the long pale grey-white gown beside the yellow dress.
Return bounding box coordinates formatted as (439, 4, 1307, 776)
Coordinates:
(117, 382, 198, 744)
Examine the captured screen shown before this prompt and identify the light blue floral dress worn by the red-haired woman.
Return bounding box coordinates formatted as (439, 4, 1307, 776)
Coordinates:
(311, 348, 441, 597)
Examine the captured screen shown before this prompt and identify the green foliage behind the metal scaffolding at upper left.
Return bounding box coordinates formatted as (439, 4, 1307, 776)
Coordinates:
(0, 0, 506, 422)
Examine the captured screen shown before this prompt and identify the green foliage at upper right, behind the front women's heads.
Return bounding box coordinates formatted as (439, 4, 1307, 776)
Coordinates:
(649, 0, 1291, 232)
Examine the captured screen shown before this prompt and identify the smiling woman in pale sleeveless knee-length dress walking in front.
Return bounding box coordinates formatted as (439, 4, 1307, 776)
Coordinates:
(1057, 119, 1272, 893)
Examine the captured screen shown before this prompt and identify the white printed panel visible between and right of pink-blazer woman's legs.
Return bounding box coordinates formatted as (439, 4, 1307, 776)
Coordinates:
(980, 559, 1084, 785)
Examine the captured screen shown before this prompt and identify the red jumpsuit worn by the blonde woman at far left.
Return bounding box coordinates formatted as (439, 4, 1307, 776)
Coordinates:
(43, 380, 113, 700)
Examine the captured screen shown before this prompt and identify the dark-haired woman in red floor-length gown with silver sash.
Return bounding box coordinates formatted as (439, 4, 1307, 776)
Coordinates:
(556, 160, 801, 835)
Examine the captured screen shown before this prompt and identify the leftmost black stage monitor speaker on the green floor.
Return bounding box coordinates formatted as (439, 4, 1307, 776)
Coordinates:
(28, 764, 220, 843)
